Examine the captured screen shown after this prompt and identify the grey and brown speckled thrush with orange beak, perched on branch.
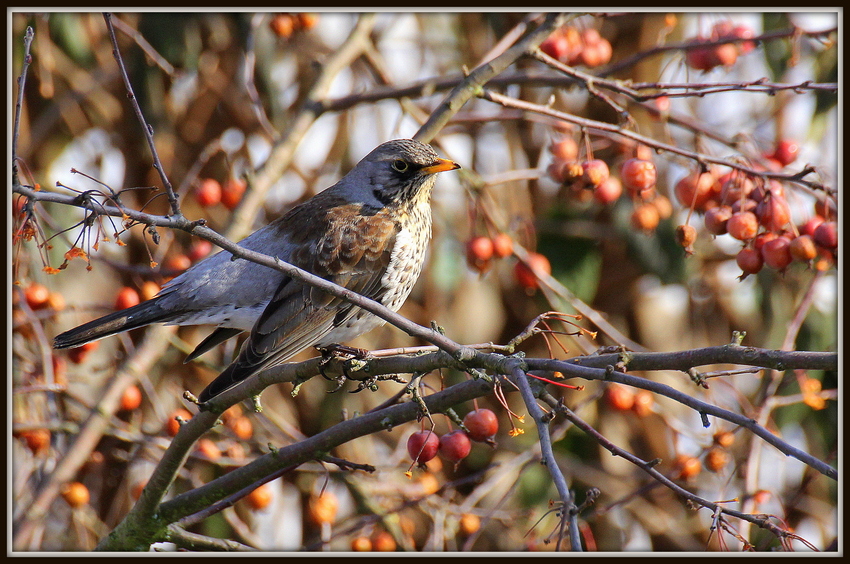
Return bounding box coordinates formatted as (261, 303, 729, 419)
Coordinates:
(53, 139, 461, 404)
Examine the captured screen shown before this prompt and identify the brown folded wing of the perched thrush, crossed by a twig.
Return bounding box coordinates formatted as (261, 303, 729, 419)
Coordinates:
(200, 204, 397, 401)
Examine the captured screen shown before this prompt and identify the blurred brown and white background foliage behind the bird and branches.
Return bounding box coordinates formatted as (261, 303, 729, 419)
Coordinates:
(9, 12, 839, 551)
